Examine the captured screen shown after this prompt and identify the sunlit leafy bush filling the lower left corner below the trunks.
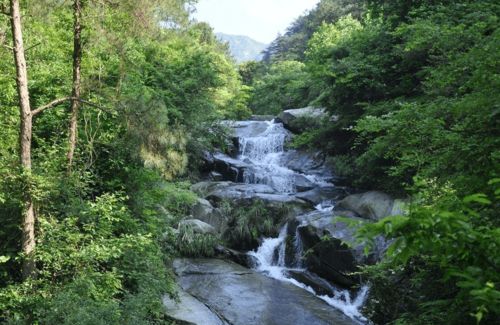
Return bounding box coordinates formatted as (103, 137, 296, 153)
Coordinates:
(0, 193, 176, 324)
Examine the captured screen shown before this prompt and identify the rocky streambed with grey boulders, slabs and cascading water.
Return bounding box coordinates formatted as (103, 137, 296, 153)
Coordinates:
(164, 111, 402, 325)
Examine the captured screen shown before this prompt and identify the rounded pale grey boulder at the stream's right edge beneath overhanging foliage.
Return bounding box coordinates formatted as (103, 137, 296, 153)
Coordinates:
(337, 191, 405, 221)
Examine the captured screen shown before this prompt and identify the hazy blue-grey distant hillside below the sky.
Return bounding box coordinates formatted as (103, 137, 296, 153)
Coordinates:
(216, 33, 267, 63)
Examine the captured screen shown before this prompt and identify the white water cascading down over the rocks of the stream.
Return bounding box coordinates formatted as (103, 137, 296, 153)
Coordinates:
(239, 121, 368, 324)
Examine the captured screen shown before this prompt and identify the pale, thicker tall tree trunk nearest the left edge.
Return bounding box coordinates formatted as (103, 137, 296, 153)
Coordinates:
(10, 0, 35, 278)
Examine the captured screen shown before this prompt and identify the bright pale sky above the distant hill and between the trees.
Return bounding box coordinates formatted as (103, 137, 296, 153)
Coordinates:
(194, 0, 319, 43)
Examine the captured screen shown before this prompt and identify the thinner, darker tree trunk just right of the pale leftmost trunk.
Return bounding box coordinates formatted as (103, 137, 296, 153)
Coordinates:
(68, 0, 82, 172)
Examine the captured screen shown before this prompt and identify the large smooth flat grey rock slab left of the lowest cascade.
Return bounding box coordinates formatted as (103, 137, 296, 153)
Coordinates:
(174, 259, 356, 325)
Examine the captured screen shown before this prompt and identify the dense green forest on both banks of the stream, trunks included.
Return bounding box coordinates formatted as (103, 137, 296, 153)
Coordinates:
(0, 0, 500, 324)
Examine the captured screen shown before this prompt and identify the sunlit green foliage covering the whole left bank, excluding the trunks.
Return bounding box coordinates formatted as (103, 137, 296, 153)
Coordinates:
(0, 0, 250, 324)
